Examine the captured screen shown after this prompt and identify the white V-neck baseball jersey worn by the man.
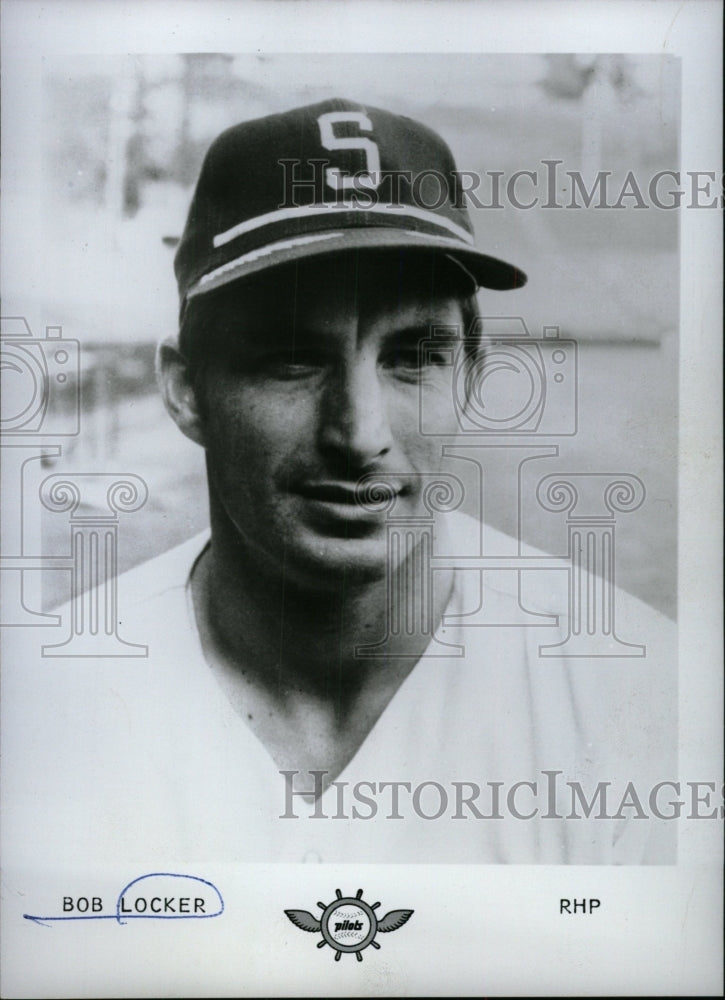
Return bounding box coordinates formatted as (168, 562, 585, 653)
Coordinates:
(5, 515, 676, 870)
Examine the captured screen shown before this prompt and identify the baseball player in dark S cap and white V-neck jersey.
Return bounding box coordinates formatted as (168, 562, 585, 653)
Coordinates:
(4, 100, 673, 863)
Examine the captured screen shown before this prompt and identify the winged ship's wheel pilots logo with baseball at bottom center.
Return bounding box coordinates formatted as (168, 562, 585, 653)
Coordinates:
(284, 889, 413, 962)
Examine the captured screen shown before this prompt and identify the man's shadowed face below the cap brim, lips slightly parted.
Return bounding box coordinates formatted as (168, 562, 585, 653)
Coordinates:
(189, 256, 462, 587)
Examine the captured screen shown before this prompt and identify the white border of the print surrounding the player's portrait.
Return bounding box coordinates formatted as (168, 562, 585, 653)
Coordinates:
(2, 0, 722, 997)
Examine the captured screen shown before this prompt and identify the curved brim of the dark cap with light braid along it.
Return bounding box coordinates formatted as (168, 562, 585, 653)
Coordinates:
(187, 226, 526, 299)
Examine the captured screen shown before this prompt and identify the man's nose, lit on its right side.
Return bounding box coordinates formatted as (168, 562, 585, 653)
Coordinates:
(320, 358, 393, 469)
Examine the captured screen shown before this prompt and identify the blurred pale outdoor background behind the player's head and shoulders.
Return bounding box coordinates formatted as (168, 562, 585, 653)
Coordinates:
(3, 54, 679, 615)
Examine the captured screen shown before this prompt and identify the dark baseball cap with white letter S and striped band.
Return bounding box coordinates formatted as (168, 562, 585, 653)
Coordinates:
(174, 98, 526, 308)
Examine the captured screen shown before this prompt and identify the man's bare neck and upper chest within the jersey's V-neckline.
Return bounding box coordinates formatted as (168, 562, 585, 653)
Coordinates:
(191, 520, 452, 781)
